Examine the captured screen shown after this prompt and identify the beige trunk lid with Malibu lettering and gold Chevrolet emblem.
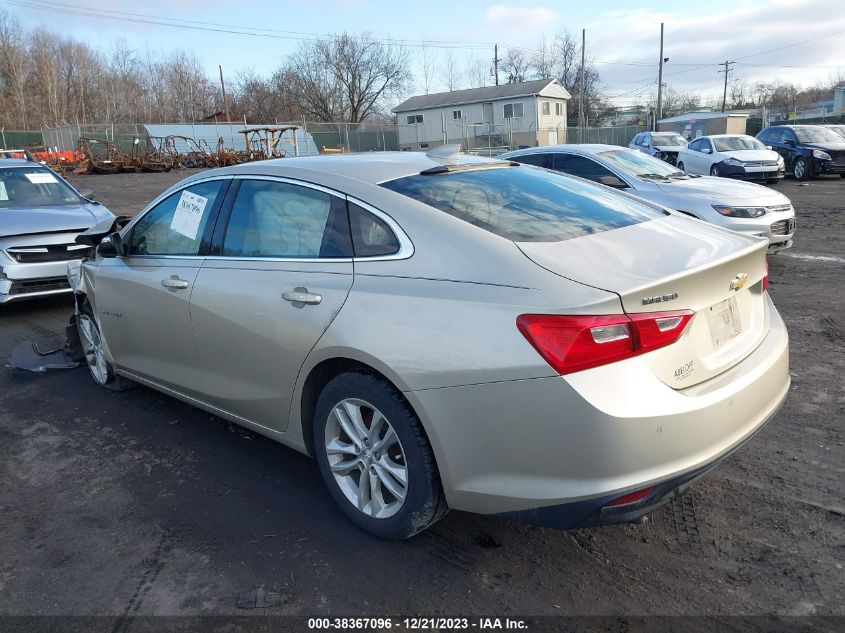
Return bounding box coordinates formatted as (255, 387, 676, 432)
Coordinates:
(518, 215, 769, 389)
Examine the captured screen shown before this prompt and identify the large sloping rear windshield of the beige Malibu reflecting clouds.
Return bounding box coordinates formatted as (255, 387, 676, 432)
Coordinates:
(382, 167, 664, 242)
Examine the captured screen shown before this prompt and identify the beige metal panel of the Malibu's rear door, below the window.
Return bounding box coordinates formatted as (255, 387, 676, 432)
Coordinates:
(191, 258, 353, 431)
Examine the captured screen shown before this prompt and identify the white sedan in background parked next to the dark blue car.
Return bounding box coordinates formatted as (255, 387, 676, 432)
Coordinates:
(677, 134, 785, 183)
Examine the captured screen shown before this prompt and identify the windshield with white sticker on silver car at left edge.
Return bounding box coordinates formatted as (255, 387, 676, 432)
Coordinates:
(0, 167, 82, 209)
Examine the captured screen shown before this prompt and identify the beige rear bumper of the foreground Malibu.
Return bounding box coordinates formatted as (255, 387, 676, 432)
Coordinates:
(406, 294, 790, 526)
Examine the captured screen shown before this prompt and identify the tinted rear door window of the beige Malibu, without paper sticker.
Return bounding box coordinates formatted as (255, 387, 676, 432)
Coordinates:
(223, 180, 352, 259)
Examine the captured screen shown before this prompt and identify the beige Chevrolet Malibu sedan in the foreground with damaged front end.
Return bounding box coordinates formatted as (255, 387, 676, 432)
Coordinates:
(69, 153, 790, 538)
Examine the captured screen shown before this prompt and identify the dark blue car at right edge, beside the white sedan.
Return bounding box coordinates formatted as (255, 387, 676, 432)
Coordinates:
(757, 125, 845, 180)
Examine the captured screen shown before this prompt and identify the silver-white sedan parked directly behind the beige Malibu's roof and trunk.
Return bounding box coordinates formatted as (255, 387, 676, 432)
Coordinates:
(499, 145, 795, 253)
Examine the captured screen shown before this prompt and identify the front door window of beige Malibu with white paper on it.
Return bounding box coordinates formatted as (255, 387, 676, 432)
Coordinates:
(128, 180, 226, 256)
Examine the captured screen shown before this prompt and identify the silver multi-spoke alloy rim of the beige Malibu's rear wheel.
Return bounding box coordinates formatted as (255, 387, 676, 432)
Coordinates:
(324, 398, 408, 519)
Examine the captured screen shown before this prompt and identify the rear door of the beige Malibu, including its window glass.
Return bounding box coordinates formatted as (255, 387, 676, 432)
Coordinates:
(190, 176, 353, 431)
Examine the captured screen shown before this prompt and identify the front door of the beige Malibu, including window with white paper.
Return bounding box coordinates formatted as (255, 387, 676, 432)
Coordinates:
(96, 178, 229, 396)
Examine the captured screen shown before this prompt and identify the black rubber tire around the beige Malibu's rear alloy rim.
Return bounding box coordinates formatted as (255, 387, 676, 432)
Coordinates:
(312, 372, 448, 539)
